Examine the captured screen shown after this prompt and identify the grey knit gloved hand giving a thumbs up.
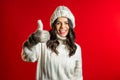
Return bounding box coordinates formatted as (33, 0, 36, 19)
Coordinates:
(29, 20, 50, 45)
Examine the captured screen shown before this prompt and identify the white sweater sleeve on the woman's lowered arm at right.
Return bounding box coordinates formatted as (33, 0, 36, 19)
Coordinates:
(72, 45, 83, 80)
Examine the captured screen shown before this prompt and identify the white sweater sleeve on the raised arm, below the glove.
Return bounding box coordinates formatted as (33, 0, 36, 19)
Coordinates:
(21, 43, 41, 62)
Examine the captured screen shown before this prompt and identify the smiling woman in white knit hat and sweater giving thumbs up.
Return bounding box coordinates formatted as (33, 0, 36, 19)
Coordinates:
(22, 6, 83, 80)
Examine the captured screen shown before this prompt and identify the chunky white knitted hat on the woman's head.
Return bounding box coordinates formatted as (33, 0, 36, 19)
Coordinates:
(50, 6, 75, 28)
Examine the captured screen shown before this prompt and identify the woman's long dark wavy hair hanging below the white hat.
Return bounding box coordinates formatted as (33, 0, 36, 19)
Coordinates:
(47, 19, 77, 56)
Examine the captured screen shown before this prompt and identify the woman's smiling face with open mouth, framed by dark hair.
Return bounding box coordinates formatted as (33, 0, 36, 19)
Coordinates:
(56, 17, 69, 37)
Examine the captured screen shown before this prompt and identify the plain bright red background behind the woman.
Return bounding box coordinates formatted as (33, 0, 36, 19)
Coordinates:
(0, 0, 120, 80)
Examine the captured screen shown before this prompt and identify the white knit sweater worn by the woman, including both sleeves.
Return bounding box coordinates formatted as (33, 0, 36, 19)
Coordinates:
(22, 40, 83, 80)
